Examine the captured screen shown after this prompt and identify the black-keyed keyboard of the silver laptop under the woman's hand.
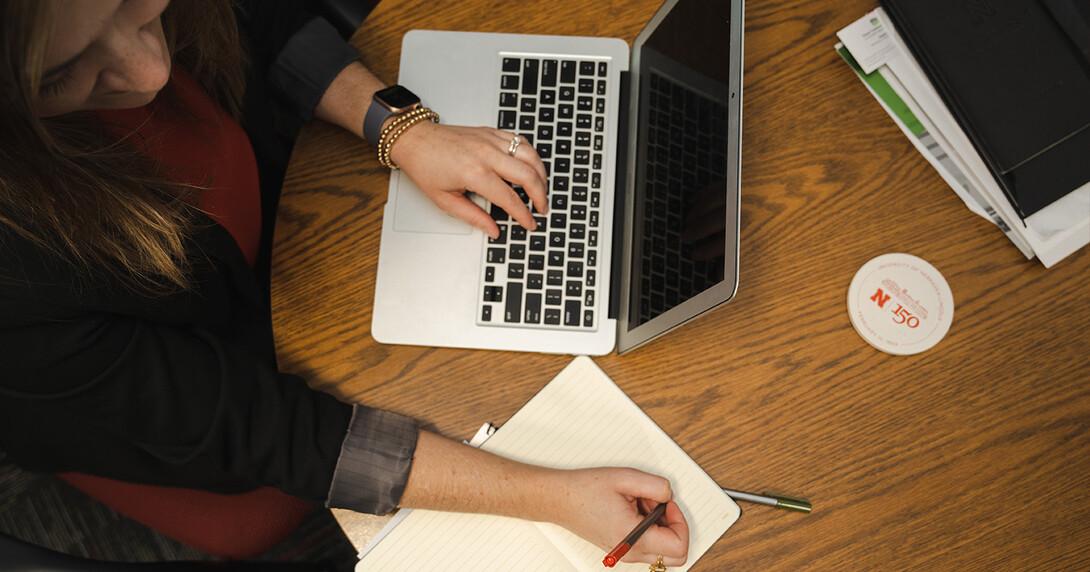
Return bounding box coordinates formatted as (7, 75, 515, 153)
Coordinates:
(477, 53, 608, 330)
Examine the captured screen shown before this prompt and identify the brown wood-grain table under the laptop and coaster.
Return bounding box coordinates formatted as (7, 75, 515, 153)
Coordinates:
(273, 0, 1090, 570)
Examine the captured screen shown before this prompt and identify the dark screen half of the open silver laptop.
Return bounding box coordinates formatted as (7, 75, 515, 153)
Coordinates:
(618, 0, 742, 352)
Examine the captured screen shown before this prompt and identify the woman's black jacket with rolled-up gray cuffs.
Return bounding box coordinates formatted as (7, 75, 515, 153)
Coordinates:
(0, 2, 415, 512)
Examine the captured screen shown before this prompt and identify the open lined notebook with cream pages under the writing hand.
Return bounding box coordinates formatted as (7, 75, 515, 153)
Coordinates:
(356, 356, 741, 572)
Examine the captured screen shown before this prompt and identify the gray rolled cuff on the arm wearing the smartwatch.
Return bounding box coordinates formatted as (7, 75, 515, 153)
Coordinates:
(268, 17, 361, 121)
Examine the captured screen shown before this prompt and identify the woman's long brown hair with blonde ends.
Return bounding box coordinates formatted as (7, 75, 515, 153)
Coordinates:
(0, 0, 244, 295)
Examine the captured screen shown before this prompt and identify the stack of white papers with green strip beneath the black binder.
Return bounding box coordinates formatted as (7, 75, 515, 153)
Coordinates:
(836, 8, 1090, 267)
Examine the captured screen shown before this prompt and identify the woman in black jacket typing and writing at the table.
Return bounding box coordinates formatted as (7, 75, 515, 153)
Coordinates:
(0, 0, 688, 565)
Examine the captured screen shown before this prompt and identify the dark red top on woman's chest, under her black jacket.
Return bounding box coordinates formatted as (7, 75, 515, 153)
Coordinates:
(98, 70, 262, 267)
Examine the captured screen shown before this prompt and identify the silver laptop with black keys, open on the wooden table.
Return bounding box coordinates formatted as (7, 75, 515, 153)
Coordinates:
(372, 0, 743, 355)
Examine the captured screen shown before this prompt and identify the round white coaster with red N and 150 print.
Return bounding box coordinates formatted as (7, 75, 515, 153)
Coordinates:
(848, 253, 954, 355)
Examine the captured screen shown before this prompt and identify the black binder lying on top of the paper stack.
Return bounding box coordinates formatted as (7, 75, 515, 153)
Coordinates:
(882, 0, 1090, 218)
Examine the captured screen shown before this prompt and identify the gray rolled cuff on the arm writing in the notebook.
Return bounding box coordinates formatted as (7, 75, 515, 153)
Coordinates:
(326, 405, 417, 514)
